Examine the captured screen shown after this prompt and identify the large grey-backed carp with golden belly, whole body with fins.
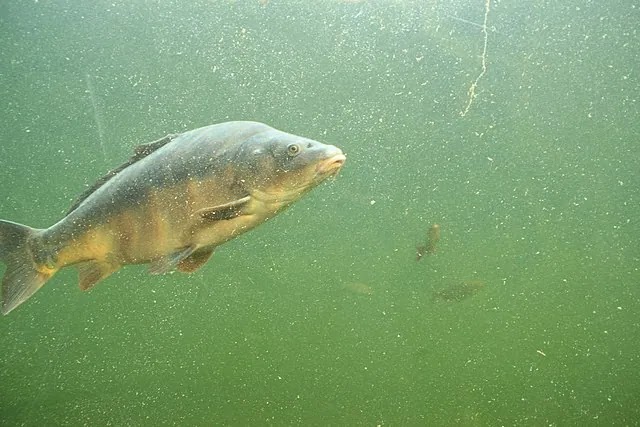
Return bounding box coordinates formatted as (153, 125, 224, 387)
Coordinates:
(0, 122, 345, 314)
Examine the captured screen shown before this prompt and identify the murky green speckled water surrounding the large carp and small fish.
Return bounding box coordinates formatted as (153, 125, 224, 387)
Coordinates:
(0, 0, 640, 426)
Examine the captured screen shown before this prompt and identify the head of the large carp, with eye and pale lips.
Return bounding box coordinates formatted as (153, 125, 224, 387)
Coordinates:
(239, 129, 346, 205)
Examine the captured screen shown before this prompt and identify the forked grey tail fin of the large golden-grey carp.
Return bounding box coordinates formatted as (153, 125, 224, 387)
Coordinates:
(0, 220, 57, 314)
